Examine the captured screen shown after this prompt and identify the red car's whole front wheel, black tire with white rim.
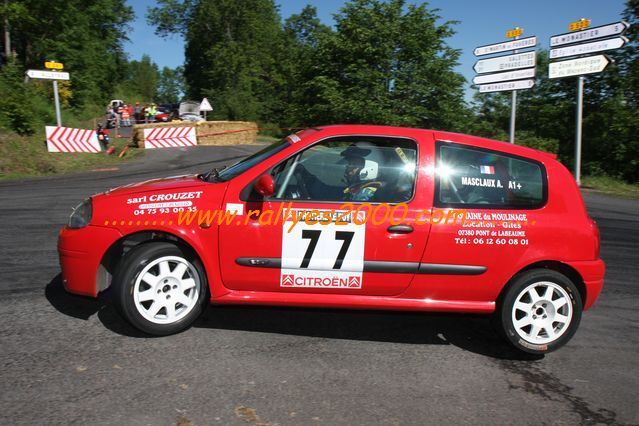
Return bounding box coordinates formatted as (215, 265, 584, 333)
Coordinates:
(112, 242, 208, 336)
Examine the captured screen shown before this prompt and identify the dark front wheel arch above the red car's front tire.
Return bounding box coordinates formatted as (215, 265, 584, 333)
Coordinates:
(95, 230, 204, 293)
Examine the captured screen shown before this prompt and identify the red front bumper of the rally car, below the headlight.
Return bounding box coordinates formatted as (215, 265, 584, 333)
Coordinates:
(58, 226, 122, 297)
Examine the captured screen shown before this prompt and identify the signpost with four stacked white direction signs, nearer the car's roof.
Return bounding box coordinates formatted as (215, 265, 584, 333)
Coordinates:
(473, 27, 537, 143)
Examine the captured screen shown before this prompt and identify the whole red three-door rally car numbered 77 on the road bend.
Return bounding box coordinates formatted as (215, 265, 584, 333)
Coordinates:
(58, 125, 605, 353)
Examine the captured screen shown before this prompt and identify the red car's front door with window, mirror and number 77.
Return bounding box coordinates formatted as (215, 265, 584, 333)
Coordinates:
(220, 136, 432, 296)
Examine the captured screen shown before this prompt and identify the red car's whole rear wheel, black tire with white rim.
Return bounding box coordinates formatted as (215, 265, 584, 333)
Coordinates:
(494, 269, 583, 355)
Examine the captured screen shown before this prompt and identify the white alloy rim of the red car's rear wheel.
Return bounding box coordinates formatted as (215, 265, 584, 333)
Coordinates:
(512, 281, 573, 345)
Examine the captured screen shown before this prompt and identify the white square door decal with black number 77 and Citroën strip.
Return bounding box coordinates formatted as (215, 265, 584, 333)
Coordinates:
(280, 209, 366, 290)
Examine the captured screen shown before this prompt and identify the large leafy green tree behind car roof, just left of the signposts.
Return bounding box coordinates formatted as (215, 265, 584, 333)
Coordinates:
(299, 0, 465, 129)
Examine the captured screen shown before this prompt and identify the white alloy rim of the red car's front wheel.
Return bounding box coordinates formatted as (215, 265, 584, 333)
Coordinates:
(133, 256, 200, 324)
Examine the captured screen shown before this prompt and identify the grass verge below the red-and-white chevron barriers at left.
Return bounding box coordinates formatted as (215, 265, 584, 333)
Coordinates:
(0, 132, 144, 180)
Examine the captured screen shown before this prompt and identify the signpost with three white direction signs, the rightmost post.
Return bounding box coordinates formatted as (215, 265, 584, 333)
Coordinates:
(548, 18, 629, 186)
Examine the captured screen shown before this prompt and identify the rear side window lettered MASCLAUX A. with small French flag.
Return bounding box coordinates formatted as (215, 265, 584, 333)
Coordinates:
(435, 142, 548, 209)
